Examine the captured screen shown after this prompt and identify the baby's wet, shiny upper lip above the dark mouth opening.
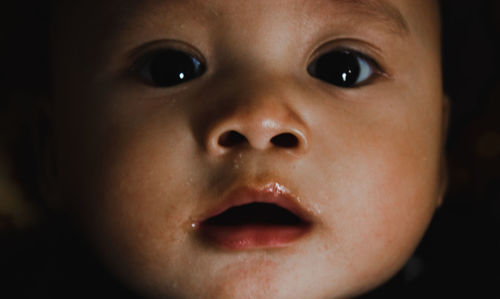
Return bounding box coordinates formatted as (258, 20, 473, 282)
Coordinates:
(199, 183, 312, 223)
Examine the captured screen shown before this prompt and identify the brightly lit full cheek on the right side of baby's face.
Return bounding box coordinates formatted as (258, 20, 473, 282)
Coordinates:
(315, 92, 442, 290)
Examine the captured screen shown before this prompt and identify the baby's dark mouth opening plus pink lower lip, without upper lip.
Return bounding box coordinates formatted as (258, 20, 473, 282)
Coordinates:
(200, 192, 311, 250)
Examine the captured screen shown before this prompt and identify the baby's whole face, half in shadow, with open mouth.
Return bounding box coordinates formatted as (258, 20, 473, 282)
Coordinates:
(48, 0, 446, 298)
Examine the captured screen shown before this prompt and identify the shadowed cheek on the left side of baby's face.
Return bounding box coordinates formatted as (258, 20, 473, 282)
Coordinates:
(56, 97, 200, 271)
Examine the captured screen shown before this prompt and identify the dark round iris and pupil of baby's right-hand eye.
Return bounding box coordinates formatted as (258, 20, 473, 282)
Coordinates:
(313, 51, 360, 87)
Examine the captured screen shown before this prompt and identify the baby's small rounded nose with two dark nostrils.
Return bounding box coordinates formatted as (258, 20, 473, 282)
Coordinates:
(205, 82, 309, 156)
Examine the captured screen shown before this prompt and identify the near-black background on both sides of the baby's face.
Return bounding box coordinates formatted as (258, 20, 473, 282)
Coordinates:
(0, 0, 500, 298)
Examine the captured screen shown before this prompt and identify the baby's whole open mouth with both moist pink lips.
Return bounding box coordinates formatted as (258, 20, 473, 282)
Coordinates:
(199, 184, 312, 250)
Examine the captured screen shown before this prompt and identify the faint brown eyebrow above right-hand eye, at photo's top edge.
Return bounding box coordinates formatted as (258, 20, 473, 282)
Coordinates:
(329, 0, 410, 36)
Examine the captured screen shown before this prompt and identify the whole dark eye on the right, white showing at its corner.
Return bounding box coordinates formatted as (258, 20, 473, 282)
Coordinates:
(307, 50, 377, 88)
